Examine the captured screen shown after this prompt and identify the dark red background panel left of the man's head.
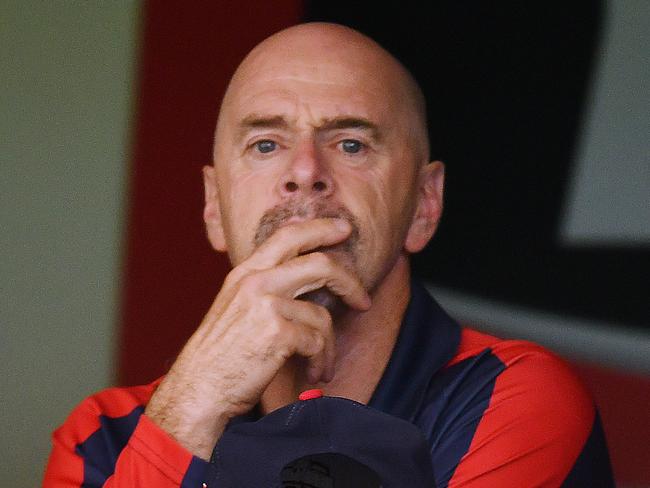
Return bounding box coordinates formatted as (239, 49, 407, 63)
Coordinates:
(118, 0, 302, 385)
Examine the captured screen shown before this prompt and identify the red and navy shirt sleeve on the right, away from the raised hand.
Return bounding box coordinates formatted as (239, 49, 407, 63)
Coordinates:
(420, 341, 614, 488)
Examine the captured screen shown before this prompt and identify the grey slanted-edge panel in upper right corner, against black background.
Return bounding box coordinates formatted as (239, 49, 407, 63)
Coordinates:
(561, 0, 650, 246)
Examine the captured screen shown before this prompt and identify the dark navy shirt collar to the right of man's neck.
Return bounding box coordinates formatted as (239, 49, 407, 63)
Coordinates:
(368, 280, 460, 422)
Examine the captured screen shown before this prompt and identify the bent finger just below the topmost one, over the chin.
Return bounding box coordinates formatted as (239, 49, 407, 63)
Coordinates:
(257, 252, 370, 311)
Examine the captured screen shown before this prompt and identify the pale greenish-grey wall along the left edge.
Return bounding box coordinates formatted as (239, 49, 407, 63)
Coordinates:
(0, 0, 139, 487)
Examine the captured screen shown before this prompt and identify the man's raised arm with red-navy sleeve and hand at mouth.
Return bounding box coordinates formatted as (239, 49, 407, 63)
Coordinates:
(45, 219, 370, 487)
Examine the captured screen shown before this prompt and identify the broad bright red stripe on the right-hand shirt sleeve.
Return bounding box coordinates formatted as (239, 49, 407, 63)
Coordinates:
(449, 338, 595, 487)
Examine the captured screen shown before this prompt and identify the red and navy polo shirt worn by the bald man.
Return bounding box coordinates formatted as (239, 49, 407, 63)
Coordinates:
(44, 281, 614, 488)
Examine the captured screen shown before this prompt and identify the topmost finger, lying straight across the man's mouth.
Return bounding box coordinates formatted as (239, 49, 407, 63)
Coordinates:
(242, 218, 352, 270)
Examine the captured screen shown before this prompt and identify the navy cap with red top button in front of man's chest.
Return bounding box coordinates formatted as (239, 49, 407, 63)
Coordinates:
(213, 391, 435, 488)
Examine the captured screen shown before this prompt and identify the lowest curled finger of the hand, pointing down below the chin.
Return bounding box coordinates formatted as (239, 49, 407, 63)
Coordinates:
(276, 298, 336, 383)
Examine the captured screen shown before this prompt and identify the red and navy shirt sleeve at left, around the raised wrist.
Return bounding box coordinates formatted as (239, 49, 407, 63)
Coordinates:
(43, 387, 209, 488)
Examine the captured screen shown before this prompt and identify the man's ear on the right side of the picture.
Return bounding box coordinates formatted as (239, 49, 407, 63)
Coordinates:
(404, 161, 445, 253)
